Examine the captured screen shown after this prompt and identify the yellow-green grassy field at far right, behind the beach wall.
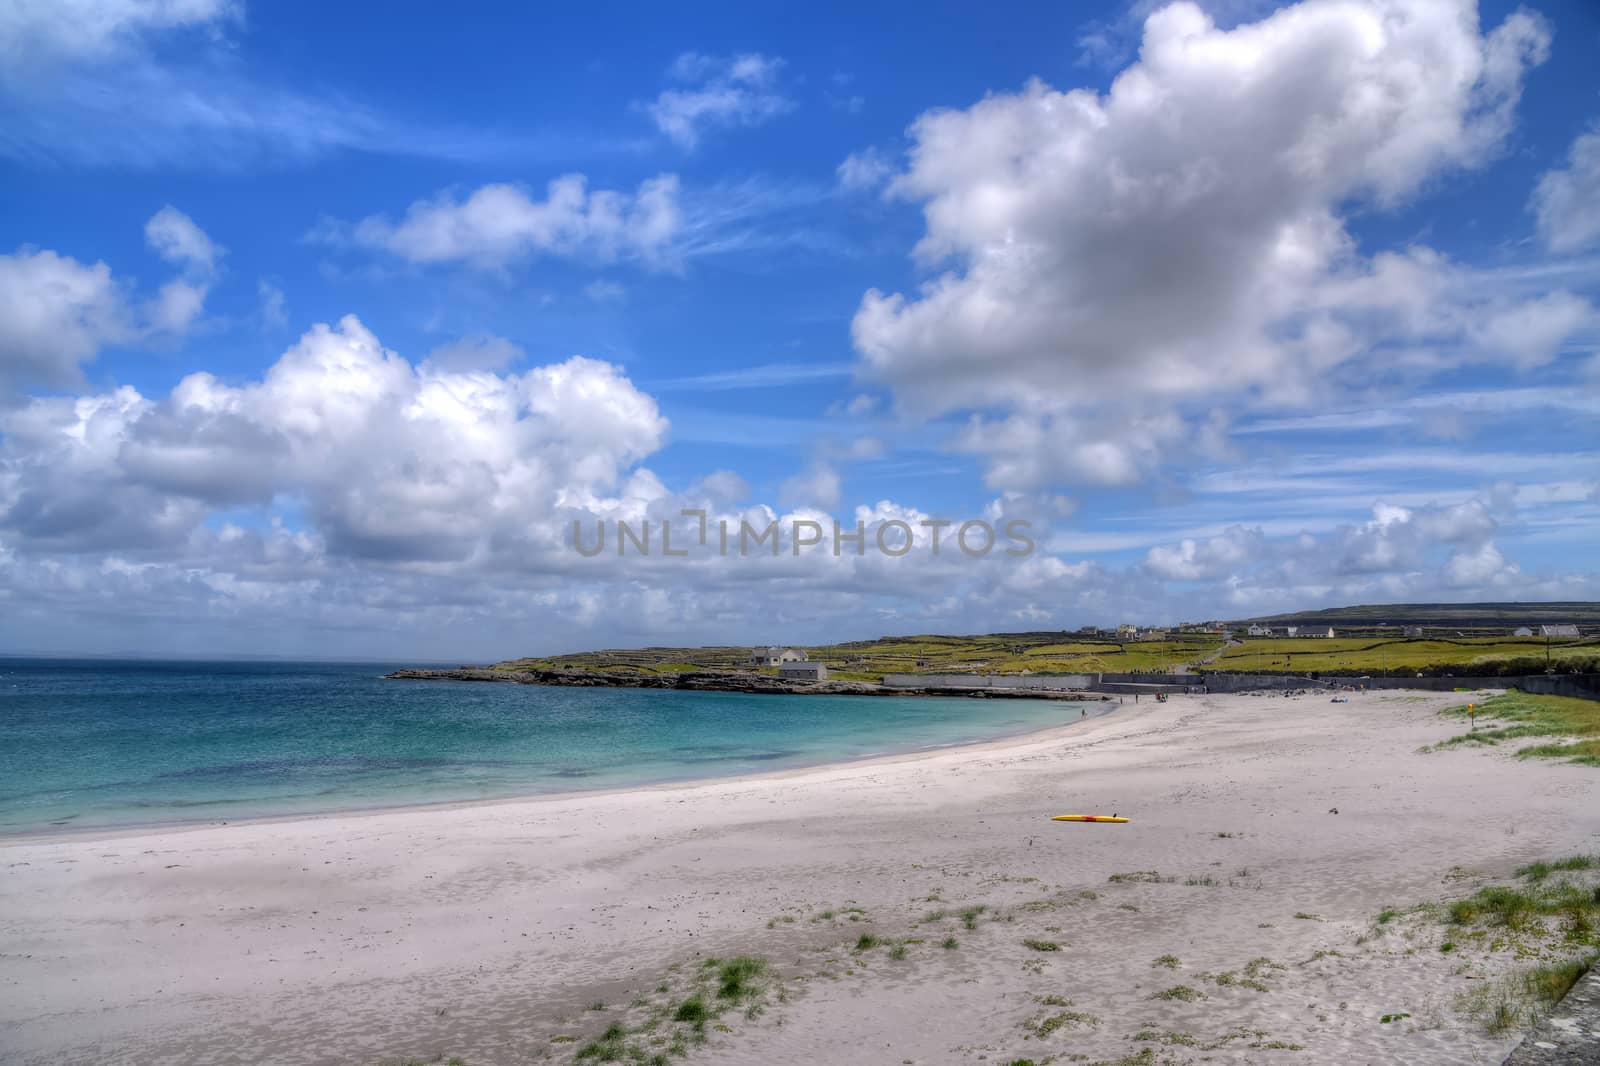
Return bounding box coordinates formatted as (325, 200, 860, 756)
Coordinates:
(1208, 637, 1600, 675)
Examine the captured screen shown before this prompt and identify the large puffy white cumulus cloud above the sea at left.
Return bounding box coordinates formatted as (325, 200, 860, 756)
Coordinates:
(0, 317, 666, 562)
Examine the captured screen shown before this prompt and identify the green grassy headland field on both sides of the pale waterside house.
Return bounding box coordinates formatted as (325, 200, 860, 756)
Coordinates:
(496, 632, 1222, 680)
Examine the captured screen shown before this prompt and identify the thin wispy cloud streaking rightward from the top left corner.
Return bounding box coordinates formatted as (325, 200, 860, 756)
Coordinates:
(0, 0, 642, 171)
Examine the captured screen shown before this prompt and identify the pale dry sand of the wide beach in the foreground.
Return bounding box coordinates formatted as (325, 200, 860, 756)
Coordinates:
(0, 691, 1600, 1066)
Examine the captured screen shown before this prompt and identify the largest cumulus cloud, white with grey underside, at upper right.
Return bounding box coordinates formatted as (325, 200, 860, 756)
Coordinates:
(853, 0, 1561, 487)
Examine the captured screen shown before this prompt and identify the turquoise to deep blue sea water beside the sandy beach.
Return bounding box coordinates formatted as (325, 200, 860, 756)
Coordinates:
(0, 658, 1104, 832)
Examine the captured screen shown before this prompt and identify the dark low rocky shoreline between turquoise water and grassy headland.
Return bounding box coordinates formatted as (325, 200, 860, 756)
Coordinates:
(386, 666, 1106, 703)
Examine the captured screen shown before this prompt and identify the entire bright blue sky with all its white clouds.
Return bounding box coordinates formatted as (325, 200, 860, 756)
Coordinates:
(0, 0, 1600, 661)
